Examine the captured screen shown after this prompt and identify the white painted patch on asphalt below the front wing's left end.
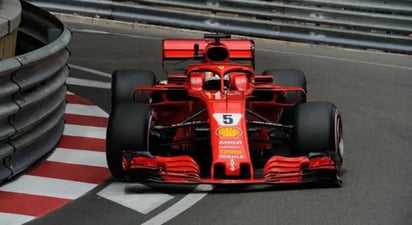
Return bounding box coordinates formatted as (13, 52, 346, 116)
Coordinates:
(97, 182, 173, 214)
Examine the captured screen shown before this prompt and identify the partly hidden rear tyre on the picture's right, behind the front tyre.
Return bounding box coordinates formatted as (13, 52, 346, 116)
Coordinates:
(263, 69, 306, 124)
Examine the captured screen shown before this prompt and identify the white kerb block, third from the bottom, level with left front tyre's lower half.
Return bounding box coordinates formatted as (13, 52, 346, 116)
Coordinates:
(47, 148, 107, 168)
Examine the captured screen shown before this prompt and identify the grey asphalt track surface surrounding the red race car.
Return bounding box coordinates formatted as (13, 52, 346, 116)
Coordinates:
(28, 19, 412, 225)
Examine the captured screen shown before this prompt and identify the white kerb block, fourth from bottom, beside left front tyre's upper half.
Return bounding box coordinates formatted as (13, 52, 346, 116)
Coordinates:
(63, 124, 106, 139)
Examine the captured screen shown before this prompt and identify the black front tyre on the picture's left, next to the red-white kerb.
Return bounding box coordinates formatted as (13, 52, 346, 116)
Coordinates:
(106, 103, 150, 179)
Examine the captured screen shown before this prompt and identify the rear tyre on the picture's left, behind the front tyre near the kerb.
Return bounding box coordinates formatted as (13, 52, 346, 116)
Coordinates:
(112, 69, 156, 107)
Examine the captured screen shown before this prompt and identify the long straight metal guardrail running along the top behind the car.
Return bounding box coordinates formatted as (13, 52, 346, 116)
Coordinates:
(31, 0, 412, 53)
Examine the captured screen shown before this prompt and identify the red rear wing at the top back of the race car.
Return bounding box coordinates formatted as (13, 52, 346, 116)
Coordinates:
(162, 39, 255, 67)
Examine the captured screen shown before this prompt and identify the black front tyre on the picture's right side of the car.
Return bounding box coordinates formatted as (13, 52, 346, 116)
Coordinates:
(291, 102, 343, 165)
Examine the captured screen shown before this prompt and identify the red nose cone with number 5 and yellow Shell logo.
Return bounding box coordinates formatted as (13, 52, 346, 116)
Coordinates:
(208, 99, 253, 179)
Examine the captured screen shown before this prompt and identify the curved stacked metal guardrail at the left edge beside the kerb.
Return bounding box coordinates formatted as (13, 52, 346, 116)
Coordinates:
(0, 1, 71, 181)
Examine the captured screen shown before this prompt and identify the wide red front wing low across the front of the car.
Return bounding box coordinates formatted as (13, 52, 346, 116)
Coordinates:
(123, 152, 341, 185)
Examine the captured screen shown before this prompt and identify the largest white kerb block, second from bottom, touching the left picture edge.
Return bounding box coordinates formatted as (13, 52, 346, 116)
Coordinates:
(0, 175, 96, 200)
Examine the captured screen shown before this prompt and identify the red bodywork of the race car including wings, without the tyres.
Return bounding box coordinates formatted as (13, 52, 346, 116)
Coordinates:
(123, 36, 338, 183)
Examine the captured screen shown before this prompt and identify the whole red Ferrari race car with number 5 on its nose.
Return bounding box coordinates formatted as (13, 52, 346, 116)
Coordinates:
(106, 34, 343, 185)
